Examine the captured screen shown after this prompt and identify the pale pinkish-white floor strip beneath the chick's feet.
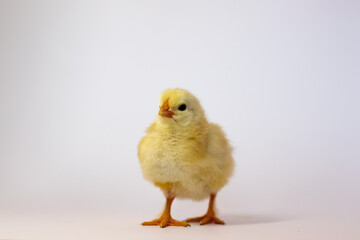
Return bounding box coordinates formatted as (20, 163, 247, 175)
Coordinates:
(0, 214, 360, 240)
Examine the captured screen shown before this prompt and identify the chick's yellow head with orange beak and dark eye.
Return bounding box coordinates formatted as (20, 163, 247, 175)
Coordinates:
(158, 88, 205, 126)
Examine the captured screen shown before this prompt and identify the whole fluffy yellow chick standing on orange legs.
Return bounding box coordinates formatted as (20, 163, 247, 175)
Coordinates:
(138, 88, 234, 227)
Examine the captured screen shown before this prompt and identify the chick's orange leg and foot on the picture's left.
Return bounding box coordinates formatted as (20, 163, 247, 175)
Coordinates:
(141, 197, 190, 228)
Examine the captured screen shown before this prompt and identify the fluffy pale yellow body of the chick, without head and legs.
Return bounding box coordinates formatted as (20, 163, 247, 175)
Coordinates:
(139, 122, 233, 200)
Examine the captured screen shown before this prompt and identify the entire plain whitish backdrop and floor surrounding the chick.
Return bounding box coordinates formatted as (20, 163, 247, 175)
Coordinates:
(0, 0, 360, 239)
